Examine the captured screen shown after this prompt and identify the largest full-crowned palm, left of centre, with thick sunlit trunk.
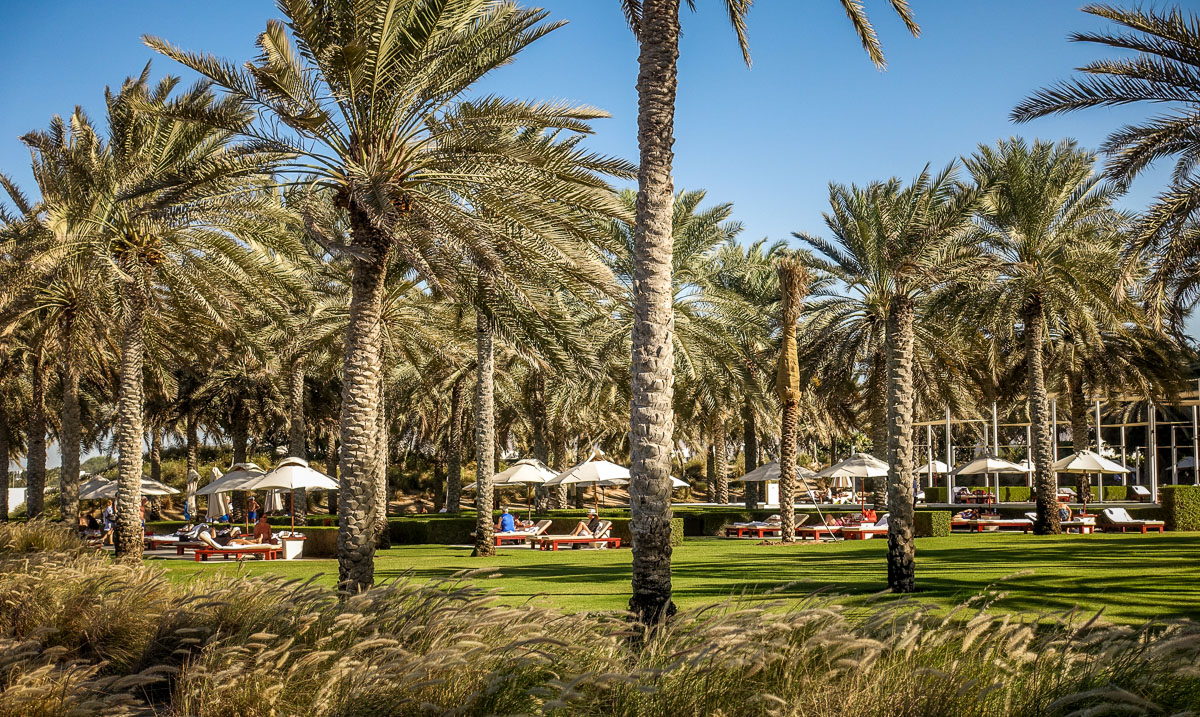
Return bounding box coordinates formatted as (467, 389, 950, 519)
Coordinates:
(146, 0, 628, 591)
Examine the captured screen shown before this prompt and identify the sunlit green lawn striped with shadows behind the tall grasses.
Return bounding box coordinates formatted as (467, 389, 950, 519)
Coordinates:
(148, 532, 1200, 622)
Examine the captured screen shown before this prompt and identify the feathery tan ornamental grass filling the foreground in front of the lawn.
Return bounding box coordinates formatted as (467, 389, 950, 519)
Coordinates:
(11, 526, 1200, 716)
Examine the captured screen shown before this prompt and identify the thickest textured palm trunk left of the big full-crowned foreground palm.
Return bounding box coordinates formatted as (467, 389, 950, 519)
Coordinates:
(113, 273, 146, 564)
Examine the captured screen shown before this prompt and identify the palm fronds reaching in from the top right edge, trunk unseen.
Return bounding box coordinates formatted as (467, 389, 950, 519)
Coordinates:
(1012, 4, 1200, 327)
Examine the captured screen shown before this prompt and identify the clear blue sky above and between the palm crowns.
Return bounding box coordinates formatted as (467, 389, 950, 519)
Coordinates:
(0, 0, 1196, 470)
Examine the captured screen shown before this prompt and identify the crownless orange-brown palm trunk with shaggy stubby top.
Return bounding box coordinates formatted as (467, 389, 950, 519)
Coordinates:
(775, 257, 808, 543)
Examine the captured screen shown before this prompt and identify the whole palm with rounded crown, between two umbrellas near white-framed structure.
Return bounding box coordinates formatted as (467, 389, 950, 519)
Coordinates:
(959, 139, 1124, 535)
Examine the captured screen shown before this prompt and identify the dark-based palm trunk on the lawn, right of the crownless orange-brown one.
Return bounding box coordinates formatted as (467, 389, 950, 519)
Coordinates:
(887, 294, 917, 592)
